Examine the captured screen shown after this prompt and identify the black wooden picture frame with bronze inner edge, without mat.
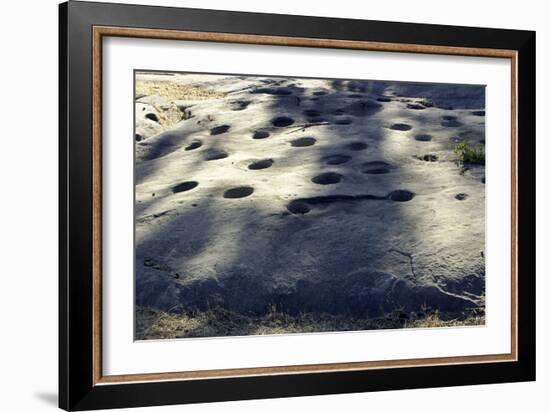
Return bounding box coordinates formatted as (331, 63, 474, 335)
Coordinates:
(59, 1, 535, 410)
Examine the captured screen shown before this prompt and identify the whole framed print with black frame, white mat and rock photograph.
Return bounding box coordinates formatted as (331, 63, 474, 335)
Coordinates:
(59, 1, 535, 410)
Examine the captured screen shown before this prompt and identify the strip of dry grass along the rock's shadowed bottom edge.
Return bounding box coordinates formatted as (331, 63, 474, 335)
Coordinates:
(136, 307, 485, 340)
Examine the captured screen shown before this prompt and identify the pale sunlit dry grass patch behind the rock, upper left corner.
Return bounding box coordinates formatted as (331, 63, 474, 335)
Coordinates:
(136, 80, 225, 100)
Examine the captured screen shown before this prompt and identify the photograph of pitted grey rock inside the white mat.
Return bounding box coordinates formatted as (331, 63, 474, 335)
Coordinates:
(133, 69, 486, 340)
